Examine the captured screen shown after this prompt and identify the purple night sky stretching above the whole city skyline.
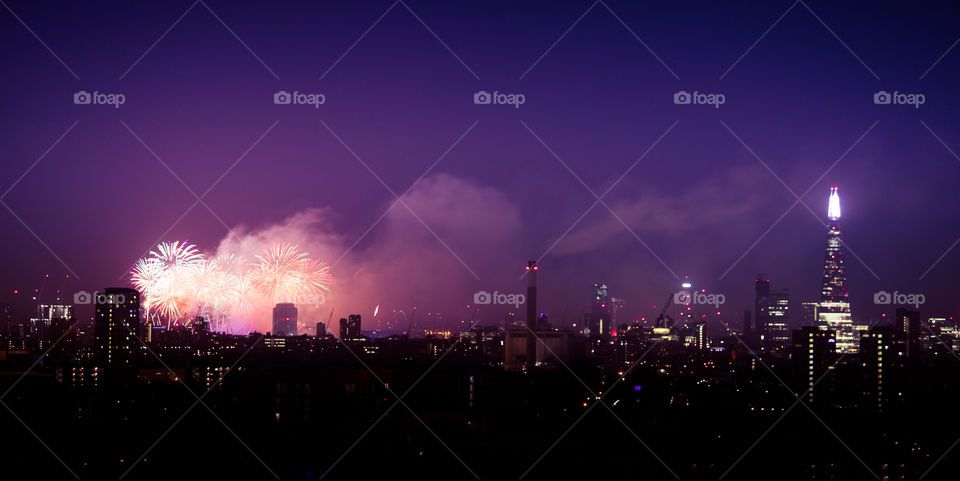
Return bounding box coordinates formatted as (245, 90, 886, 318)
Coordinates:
(0, 0, 960, 329)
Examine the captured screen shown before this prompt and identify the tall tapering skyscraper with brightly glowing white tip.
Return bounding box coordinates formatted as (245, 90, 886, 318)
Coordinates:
(817, 187, 860, 354)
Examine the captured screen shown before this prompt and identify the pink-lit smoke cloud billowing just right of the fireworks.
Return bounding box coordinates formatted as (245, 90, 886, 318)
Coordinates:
(217, 175, 522, 332)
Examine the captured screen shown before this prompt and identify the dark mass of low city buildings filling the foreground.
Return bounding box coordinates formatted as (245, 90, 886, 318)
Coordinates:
(0, 280, 960, 480)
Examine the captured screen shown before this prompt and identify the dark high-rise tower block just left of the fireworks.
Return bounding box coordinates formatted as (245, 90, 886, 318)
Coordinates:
(93, 287, 141, 370)
